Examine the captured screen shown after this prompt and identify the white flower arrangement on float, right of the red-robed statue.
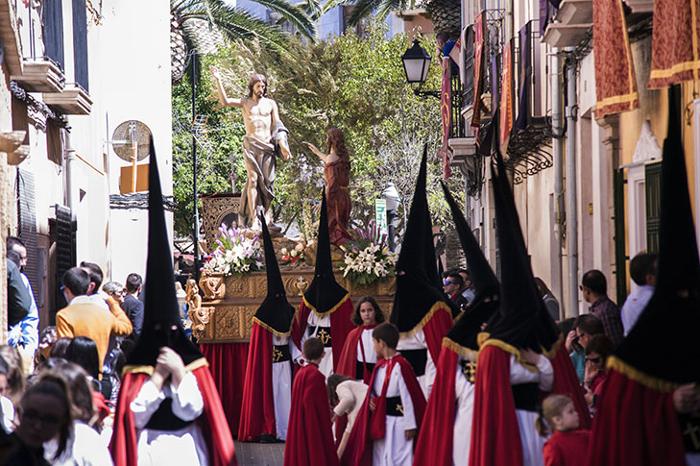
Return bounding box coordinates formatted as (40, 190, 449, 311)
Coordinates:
(340, 228, 398, 286)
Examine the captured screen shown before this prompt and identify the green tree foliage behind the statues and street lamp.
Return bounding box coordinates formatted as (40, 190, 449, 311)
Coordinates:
(173, 25, 464, 237)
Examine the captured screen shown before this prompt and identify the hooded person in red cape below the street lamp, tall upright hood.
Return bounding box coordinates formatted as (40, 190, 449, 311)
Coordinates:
(389, 145, 457, 398)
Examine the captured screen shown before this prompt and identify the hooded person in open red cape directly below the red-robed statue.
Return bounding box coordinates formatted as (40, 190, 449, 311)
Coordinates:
(292, 191, 353, 377)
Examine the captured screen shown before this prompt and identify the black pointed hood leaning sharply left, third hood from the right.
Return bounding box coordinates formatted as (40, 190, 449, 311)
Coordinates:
(442, 182, 499, 351)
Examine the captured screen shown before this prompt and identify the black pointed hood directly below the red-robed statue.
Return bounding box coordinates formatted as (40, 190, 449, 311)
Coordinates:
(304, 190, 348, 314)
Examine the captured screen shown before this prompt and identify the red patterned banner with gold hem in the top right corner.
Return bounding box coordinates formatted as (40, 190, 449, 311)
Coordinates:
(649, 0, 700, 89)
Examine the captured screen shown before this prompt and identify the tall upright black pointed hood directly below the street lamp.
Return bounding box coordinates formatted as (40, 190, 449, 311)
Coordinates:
(390, 145, 452, 333)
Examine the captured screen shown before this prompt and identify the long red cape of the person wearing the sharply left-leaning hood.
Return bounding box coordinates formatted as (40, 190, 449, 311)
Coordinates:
(413, 338, 459, 466)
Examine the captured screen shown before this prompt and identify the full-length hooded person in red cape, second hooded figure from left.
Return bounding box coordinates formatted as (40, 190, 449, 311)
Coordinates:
(238, 215, 294, 442)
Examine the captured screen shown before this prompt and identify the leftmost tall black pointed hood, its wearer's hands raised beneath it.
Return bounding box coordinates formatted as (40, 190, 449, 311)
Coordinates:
(127, 137, 203, 366)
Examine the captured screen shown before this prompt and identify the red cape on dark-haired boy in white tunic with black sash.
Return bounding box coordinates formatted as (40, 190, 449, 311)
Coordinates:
(340, 354, 425, 466)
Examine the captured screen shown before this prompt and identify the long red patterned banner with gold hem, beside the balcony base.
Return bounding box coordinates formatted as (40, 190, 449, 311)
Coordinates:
(593, 0, 639, 119)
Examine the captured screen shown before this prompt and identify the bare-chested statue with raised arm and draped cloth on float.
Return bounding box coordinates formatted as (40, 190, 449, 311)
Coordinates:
(212, 69, 291, 231)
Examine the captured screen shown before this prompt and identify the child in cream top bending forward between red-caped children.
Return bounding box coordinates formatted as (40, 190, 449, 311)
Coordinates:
(328, 374, 367, 457)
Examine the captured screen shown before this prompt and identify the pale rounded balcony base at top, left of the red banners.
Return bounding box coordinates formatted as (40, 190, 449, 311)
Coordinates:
(543, 0, 593, 47)
